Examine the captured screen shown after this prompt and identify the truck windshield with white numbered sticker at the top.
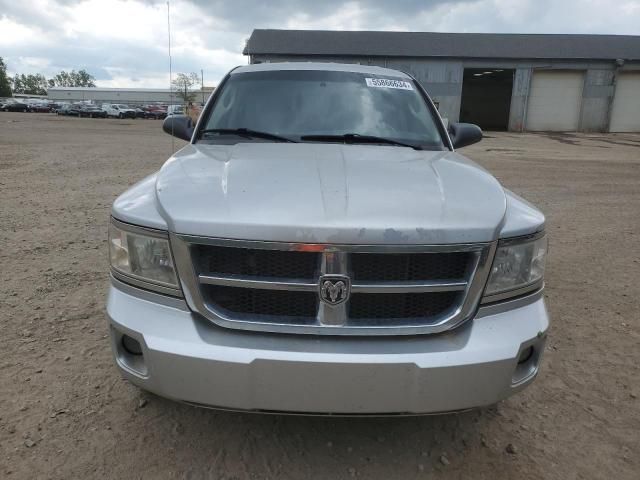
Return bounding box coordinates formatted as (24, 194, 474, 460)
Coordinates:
(203, 70, 444, 149)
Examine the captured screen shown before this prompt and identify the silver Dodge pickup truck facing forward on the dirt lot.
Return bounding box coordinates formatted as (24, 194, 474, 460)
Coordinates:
(107, 63, 549, 415)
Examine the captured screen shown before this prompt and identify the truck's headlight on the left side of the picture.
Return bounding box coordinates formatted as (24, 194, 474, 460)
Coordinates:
(109, 220, 181, 295)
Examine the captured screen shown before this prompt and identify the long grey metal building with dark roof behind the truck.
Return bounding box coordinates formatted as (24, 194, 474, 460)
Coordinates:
(243, 30, 640, 131)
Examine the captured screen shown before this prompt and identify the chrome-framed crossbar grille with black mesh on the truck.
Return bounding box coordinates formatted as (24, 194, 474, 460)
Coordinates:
(171, 235, 495, 335)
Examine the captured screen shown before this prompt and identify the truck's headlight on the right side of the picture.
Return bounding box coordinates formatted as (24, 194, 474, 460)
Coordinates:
(484, 232, 547, 301)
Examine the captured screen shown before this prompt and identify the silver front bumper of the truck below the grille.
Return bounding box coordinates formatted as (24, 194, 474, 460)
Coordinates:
(107, 279, 549, 415)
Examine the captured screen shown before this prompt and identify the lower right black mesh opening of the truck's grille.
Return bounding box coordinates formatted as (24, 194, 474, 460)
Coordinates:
(349, 292, 460, 320)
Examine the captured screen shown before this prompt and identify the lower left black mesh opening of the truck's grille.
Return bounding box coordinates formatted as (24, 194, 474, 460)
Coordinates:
(204, 285, 318, 323)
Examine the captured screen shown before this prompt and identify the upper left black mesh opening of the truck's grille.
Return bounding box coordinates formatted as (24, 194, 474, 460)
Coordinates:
(193, 245, 320, 280)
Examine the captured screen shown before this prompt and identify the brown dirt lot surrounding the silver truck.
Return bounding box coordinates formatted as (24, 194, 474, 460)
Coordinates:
(0, 113, 640, 480)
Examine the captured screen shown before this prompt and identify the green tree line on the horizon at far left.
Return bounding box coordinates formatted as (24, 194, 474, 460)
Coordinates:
(0, 57, 96, 97)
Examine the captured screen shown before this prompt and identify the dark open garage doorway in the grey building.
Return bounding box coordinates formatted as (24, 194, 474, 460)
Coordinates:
(460, 68, 515, 130)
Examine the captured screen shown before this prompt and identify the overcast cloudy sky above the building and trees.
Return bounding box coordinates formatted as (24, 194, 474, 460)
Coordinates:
(0, 0, 640, 87)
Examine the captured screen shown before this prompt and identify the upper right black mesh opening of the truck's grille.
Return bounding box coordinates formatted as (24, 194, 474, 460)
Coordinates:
(351, 252, 471, 282)
